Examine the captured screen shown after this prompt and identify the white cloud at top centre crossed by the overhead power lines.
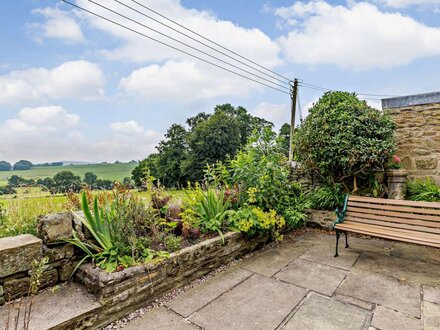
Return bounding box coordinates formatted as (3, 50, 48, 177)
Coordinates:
(76, 0, 281, 67)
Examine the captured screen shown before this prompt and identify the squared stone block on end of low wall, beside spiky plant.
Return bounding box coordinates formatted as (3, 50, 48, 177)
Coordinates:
(38, 212, 73, 244)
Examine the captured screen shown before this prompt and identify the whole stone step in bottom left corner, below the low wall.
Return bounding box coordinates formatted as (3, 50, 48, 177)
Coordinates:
(0, 283, 101, 330)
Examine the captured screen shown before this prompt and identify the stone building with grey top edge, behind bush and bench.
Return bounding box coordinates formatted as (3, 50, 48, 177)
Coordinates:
(382, 92, 440, 184)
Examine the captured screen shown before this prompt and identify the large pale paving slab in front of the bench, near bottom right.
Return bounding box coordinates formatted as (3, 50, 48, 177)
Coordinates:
(337, 271, 421, 317)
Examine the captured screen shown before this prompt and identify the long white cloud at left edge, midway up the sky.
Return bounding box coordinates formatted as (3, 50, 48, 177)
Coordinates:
(0, 61, 105, 105)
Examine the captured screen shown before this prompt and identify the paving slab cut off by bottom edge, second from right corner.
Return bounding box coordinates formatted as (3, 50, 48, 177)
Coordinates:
(371, 306, 422, 330)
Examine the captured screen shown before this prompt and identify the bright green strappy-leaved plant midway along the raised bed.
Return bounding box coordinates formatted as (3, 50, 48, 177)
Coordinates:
(196, 189, 235, 241)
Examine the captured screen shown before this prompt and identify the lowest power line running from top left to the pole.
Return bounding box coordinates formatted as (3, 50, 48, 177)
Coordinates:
(61, 0, 290, 95)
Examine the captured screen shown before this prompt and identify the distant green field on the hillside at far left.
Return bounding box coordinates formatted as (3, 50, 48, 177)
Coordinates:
(0, 163, 137, 186)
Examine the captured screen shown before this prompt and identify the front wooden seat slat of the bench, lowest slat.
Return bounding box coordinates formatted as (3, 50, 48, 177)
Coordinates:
(340, 223, 440, 244)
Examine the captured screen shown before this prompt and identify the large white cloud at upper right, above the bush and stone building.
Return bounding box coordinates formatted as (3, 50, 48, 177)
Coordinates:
(275, 1, 440, 70)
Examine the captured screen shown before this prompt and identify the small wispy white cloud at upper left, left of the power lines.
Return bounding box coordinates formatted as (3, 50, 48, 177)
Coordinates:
(27, 7, 84, 43)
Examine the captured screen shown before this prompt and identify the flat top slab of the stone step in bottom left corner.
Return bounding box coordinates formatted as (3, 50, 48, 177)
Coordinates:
(0, 284, 100, 330)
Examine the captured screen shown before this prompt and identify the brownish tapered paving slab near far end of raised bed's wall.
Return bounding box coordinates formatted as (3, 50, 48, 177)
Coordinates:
(241, 243, 308, 277)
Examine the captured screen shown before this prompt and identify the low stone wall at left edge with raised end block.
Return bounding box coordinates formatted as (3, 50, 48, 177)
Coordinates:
(0, 213, 76, 305)
